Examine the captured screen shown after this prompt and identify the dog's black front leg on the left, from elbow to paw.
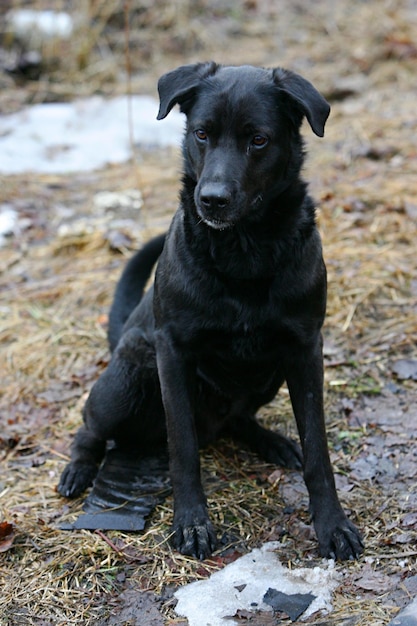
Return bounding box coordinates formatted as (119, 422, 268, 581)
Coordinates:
(156, 331, 216, 560)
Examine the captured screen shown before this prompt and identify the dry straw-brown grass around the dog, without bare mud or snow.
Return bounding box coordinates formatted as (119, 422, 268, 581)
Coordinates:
(0, 0, 417, 626)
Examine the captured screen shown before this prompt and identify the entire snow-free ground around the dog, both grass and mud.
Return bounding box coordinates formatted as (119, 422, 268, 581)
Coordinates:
(0, 0, 417, 626)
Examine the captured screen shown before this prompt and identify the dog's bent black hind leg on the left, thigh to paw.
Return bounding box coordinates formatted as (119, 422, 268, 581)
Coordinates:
(58, 328, 166, 498)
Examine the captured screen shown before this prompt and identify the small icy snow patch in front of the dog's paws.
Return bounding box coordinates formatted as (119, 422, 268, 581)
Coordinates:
(174, 542, 340, 626)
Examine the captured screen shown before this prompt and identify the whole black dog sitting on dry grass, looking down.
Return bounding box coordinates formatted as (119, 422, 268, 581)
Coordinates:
(59, 63, 363, 559)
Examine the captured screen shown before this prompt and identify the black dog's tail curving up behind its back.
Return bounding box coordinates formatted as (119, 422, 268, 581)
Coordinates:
(108, 234, 165, 352)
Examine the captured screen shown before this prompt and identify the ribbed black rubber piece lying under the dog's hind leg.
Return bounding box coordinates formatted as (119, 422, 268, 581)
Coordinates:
(60, 448, 171, 531)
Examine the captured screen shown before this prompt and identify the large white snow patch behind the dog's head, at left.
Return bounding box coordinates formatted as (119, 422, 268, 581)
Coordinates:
(0, 96, 184, 175)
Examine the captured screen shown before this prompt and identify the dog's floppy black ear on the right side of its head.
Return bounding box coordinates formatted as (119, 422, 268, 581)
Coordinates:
(273, 67, 330, 137)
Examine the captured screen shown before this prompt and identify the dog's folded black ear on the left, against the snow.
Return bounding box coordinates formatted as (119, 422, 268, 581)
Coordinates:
(156, 61, 219, 120)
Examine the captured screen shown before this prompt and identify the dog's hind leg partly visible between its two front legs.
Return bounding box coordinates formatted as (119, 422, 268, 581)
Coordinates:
(227, 416, 303, 470)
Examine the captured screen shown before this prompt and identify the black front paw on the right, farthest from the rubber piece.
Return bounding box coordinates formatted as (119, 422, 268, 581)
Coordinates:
(315, 514, 364, 561)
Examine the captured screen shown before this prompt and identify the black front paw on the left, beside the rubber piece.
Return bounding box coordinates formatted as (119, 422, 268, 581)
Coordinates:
(171, 507, 217, 561)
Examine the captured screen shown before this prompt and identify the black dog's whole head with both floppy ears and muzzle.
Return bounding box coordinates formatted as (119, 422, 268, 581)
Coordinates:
(158, 62, 330, 229)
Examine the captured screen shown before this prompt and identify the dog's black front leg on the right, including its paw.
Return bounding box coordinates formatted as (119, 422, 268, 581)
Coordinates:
(286, 337, 363, 559)
